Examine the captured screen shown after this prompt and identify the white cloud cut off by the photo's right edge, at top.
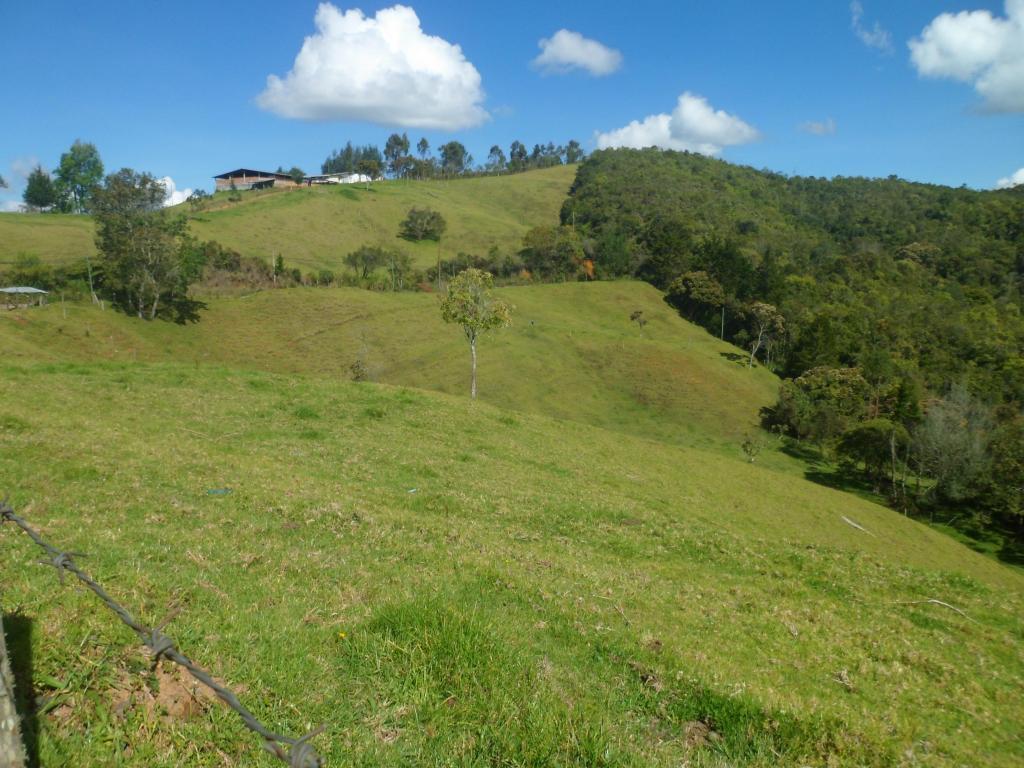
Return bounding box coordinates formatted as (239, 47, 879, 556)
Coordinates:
(907, 0, 1024, 113)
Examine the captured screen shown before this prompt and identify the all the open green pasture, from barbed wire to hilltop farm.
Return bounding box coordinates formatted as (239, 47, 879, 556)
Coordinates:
(0, 157, 1024, 768)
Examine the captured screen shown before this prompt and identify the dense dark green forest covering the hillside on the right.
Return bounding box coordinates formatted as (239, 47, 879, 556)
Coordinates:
(561, 150, 1024, 548)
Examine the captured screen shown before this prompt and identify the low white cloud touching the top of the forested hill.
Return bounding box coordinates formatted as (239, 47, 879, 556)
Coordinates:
(596, 91, 758, 155)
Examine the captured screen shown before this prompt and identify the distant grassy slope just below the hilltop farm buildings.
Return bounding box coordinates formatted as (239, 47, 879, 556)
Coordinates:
(0, 166, 575, 270)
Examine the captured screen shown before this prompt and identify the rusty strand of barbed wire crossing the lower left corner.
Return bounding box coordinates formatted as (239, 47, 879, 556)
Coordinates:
(0, 502, 327, 768)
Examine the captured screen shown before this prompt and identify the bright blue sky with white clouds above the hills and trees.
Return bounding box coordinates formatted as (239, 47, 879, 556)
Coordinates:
(0, 0, 1024, 207)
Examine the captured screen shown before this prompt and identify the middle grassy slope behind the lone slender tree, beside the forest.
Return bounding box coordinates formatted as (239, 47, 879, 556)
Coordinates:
(0, 283, 778, 458)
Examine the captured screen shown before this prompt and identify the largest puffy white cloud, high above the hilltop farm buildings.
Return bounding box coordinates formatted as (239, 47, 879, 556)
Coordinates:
(256, 3, 489, 130)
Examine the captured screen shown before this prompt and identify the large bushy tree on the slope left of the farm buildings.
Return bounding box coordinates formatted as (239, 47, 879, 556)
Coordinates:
(90, 168, 202, 321)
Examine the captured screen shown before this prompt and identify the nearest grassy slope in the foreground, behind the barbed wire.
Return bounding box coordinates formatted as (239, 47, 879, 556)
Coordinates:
(0, 362, 1024, 766)
